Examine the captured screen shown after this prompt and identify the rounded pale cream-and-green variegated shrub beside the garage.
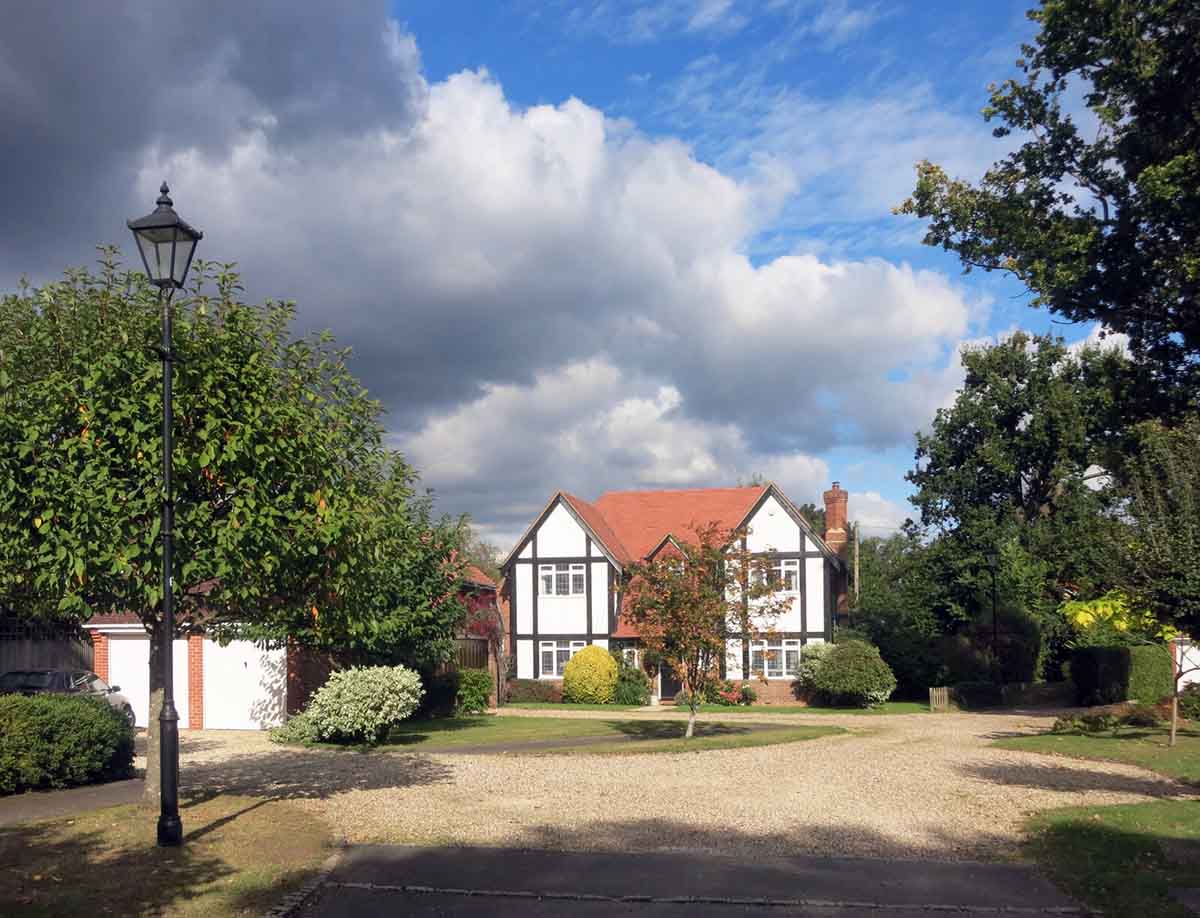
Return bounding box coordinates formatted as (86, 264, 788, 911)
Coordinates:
(307, 666, 424, 743)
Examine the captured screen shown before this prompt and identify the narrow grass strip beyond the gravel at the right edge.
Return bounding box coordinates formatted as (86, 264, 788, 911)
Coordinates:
(995, 726, 1200, 782)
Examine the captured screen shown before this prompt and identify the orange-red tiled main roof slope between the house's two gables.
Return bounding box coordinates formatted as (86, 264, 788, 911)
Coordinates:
(589, 485, 767, 559)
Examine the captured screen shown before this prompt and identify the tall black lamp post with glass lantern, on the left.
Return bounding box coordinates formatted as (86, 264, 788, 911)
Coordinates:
(126, 182, 204, 847)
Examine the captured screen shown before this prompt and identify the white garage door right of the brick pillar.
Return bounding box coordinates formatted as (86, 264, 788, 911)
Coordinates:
(204, 638, 288, 730)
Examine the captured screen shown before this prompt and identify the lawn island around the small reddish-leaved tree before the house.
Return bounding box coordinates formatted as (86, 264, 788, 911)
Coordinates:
(304, 715, 845, 755)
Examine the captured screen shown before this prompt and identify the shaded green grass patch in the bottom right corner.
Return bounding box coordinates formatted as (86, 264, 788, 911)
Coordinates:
(1026, 796, 1200, 918)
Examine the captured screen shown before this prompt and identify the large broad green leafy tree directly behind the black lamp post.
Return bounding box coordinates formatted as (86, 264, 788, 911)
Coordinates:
(0, 250, 457, 798)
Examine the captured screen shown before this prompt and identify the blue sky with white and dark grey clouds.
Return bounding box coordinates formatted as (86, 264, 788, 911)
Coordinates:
(0, 0, 1096, 551)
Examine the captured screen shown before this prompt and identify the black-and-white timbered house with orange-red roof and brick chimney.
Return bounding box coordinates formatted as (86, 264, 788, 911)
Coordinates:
(500, 481, 847, 701)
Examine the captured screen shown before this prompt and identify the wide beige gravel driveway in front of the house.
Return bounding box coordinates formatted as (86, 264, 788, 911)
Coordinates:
(169, 714, 1194, 860)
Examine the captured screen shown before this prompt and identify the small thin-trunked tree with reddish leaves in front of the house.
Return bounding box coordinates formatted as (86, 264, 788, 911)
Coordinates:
(622, 523, 791, 737)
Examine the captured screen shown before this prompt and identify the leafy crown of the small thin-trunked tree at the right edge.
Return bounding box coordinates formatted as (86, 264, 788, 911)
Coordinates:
(1123, 418, 1200, 634)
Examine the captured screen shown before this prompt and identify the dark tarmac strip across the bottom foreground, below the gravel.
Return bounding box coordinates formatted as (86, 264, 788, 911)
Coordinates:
(299, 845, 1084, 918)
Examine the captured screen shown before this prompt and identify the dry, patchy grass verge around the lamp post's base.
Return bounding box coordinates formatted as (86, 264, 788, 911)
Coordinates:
(0, 796, 329, 918)
